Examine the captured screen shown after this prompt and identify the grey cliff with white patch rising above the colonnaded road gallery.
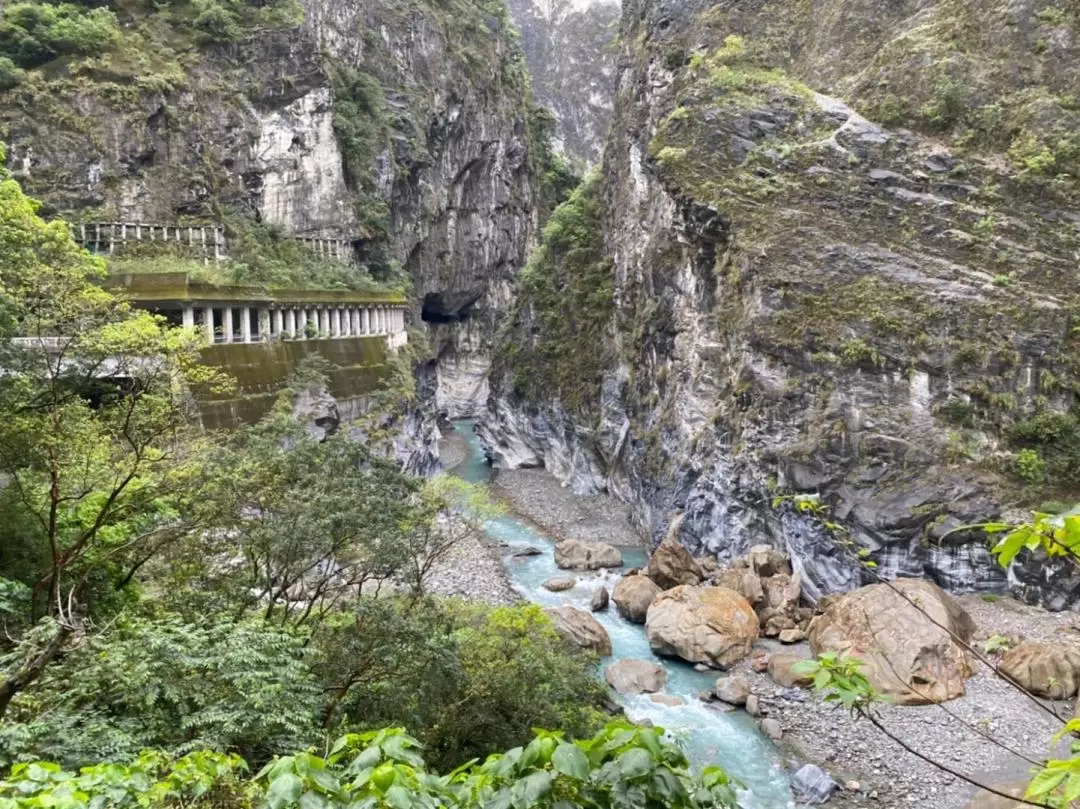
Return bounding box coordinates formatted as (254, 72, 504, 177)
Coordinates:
(0, 0, 538, 432)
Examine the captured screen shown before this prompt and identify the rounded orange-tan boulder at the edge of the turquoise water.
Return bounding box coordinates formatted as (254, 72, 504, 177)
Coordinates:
(645, 584, 758, 669)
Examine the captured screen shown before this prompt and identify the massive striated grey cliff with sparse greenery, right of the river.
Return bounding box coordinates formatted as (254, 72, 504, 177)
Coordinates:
(483, 0, 1080, 607)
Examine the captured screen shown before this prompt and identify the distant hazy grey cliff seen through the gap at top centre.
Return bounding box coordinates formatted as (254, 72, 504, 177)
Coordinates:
(507, 0, 619, 166)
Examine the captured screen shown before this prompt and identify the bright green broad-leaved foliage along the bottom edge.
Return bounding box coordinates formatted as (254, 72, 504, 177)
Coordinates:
(0, 725, 735, 809)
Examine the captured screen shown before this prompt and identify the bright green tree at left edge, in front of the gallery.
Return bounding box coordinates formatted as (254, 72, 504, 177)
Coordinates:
(0, 159, 220, 716)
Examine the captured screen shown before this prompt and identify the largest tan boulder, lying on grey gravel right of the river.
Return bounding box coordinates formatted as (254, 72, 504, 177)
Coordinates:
(809, 579, 975, 705)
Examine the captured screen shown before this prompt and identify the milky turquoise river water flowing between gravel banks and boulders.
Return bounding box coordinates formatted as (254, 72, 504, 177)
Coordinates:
(454, 421, 794, 809)
